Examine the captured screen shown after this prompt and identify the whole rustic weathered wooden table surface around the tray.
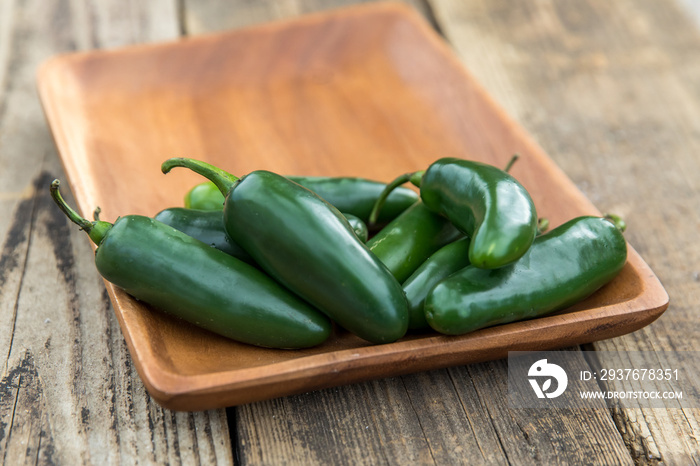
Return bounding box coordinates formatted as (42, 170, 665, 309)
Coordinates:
(0, 0, 700, 465)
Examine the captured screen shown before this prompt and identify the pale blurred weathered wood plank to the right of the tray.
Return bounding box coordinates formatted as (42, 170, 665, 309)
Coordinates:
(432, 0, 700, 464)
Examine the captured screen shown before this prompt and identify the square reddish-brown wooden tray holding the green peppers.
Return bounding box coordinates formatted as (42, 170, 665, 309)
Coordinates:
(38, 4, 668, 410)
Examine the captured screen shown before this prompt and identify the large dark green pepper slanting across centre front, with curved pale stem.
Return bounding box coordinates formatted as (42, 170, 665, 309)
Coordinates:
(162, 159, 408, 343)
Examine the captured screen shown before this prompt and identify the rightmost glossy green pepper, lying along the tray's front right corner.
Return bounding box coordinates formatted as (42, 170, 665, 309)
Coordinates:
(424, 217, 627, 335)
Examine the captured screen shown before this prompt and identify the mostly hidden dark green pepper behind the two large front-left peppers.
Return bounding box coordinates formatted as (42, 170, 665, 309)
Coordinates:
(153, 207, 369, 265)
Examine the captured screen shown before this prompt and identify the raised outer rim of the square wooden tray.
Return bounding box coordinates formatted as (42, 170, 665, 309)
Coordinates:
(37, 2, 669, 411)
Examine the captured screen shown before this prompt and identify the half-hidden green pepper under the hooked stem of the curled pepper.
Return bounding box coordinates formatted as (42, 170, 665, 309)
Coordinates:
(367, 202, 463, 282)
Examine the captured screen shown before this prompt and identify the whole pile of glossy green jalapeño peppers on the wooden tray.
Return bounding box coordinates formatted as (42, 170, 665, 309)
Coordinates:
(51, 158, 627, 349)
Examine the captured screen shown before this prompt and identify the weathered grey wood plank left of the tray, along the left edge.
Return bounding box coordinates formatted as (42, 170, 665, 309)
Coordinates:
(0, 0, 232, 464)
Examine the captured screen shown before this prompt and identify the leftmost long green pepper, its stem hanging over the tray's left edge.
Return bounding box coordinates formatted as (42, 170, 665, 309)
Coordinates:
(51, 181, 332, 348)
